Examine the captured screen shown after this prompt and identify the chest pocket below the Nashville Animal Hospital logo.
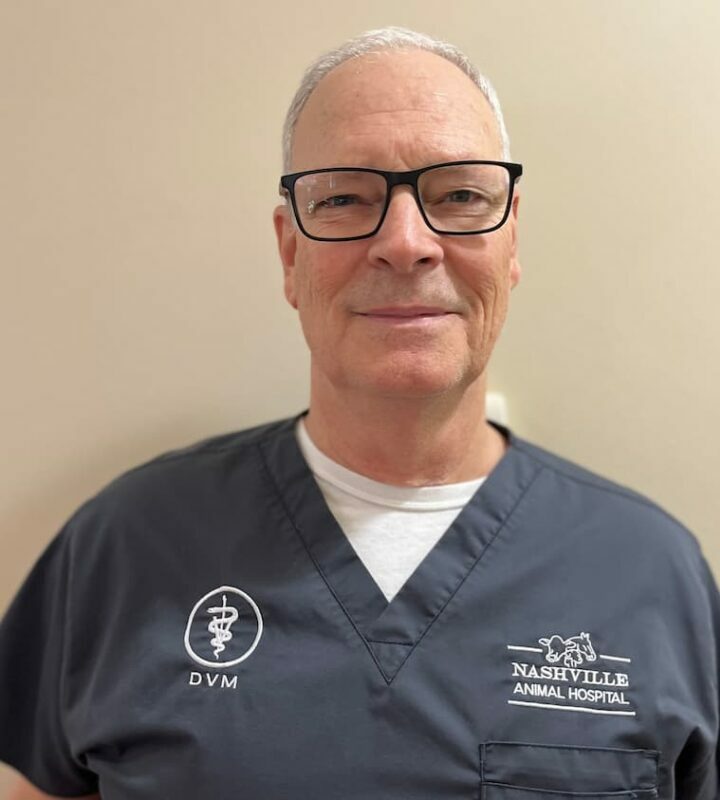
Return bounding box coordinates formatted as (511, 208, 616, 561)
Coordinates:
(480, 742, 659, 800)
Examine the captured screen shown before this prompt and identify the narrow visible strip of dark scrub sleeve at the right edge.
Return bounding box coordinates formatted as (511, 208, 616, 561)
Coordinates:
(675, 556, 720, 800)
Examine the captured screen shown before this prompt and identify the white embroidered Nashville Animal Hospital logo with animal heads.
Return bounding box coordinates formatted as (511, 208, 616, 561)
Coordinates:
(507, 631, 636, 717)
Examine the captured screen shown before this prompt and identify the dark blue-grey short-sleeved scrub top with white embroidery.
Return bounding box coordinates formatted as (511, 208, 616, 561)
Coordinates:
(0, 417, 720, 800)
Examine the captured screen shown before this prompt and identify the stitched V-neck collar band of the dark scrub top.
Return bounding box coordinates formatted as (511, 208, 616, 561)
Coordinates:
(260, 411, 541, 682)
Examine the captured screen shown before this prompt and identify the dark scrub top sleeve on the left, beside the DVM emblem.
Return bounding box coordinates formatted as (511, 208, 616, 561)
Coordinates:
(0, 530, 98, 797)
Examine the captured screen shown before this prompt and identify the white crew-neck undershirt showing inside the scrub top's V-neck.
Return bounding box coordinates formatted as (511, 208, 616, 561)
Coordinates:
(295, 417, 485, 601)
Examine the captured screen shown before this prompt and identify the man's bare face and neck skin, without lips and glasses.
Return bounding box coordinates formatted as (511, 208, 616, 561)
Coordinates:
(274, 51, 520, 486)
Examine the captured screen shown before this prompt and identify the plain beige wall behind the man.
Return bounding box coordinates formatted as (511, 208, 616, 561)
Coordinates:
(0, 0, 720, 788)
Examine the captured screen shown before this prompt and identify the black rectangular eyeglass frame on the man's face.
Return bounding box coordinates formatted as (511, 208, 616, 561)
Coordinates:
(279, 159, 523, 242)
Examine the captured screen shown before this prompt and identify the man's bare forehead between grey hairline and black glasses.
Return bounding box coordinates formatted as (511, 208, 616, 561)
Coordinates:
(292, 50, 502, 171)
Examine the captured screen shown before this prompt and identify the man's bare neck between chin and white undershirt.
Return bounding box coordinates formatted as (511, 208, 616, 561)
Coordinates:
(305, 373, 506, 486)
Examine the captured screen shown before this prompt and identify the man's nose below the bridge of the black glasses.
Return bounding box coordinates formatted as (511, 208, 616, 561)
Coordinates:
(368, 186, 443, 272)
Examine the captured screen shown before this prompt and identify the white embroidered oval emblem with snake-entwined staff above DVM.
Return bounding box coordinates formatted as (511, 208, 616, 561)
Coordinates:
(185, 586, 263, 669)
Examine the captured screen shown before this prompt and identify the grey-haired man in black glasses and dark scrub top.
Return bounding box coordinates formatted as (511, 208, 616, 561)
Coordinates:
(0, 29, 720, 800)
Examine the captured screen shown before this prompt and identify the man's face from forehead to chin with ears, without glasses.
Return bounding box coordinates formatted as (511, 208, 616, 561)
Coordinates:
(274, 51, 520, 398)
